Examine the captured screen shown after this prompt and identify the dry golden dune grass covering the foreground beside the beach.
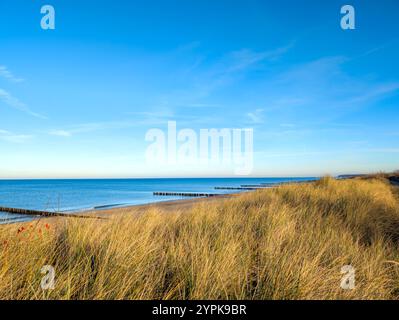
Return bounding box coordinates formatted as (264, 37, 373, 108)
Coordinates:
(0, 178, 399, 299)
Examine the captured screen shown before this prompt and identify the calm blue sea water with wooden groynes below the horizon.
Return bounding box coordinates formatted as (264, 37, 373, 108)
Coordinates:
(0, 177, 316, 223)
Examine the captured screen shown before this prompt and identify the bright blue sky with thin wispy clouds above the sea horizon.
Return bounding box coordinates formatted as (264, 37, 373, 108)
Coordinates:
(0, 0, 399, 178)
